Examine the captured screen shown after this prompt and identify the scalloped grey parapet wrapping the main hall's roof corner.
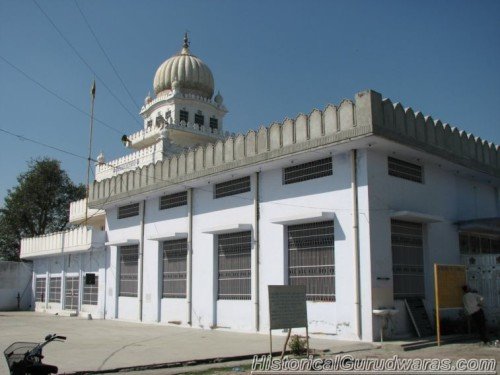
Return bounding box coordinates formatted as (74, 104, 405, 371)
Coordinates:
(89, 90, 500, 208)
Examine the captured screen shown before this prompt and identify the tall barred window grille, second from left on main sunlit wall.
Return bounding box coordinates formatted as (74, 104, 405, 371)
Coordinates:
(162, 239, 187, 298)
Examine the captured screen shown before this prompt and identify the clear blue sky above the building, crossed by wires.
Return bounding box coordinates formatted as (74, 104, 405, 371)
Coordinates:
(0, 0, 500, 202)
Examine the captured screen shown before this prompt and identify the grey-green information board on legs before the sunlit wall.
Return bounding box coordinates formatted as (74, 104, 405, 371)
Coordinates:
(268, 285, 307, 329)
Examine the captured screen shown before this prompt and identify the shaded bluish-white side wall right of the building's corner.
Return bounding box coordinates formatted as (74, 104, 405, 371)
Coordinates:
(368, 148, 498, 339)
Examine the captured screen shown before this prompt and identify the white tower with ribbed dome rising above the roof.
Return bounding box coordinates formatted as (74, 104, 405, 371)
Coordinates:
(127, 33, 227, 153)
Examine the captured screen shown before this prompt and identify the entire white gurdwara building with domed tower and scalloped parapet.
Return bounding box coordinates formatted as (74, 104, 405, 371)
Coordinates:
(21, 39, 500, 341)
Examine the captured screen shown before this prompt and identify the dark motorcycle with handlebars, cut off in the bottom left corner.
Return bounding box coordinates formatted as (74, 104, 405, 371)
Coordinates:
(3, 333, 66, 375)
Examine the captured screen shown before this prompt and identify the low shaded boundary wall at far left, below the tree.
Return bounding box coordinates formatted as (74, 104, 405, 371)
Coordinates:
(0, 261, 33, 311)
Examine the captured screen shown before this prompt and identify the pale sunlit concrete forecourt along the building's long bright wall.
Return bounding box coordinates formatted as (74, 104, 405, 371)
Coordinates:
(0, 312, 374, 374)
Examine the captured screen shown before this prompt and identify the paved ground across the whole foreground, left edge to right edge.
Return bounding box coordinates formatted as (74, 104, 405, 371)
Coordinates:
(0, 312, 500, 375)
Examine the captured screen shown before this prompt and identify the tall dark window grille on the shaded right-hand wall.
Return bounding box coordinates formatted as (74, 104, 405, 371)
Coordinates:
(391, 220, 425, 299)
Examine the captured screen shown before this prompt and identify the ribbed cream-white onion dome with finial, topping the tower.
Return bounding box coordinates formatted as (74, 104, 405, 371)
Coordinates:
(153, 36, 214, 99)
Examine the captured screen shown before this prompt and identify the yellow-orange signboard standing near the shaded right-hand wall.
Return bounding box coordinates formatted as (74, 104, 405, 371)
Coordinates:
(436, 264, 467, 309)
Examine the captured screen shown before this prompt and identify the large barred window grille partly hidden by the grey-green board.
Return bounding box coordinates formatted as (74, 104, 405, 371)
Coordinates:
(288, 221, 335, 301)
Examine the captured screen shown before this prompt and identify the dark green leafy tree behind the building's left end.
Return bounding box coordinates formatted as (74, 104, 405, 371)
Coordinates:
(0, 158, 85, 260)
